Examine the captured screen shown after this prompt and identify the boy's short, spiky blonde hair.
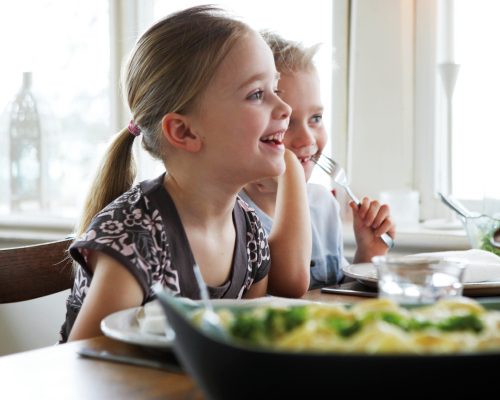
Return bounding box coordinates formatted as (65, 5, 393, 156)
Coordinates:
(261, 31, 320, 74)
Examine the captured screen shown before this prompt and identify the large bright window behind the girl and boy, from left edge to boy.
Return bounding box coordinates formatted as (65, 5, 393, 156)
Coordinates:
(0, 0, 345, 234)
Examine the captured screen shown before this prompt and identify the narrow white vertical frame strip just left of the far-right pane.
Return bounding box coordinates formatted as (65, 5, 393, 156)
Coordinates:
(414, 0, 466, 221)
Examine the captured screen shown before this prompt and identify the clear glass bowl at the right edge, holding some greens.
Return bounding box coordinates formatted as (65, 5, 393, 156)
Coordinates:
(462, 214, 500, 256)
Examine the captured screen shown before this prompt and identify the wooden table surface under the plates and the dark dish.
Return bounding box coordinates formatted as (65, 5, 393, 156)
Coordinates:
(0, 290, 363, 400)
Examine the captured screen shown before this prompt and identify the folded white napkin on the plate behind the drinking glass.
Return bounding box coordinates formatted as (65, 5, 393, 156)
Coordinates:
(416, 249, 500, 283)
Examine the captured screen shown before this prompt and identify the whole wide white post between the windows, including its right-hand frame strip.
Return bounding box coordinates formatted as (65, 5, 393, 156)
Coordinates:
(344, 0, 460, 220)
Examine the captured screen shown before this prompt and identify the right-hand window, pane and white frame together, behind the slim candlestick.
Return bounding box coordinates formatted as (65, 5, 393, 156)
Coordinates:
(415, 0, 500, 218)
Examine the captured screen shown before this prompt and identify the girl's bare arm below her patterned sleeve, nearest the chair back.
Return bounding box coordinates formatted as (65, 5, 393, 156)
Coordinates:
(68, 252, 144, 341)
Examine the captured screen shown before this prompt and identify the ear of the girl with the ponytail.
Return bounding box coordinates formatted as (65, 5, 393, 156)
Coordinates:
(161, 113, 202, 153)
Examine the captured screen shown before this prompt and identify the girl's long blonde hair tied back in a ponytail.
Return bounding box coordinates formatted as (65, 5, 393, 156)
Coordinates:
(77, 5, 251, 234)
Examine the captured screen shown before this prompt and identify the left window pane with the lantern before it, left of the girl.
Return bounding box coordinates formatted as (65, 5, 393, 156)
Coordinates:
(0, 0, 111, 223)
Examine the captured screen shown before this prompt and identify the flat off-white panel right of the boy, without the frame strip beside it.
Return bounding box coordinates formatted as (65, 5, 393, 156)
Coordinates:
(344, 0, 417, 214)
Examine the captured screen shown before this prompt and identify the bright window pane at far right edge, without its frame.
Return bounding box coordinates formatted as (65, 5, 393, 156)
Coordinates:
(450, 0, 500, 212)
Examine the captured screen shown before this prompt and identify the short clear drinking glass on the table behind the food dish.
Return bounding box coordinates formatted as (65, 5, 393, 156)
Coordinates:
(372, 256, 465, 304)
